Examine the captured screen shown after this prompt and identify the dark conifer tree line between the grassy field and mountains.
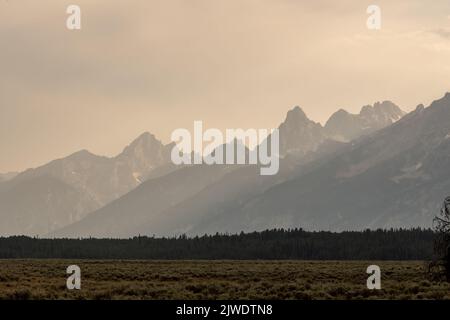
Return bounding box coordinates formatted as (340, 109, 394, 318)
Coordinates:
(0, 228, 436, 260)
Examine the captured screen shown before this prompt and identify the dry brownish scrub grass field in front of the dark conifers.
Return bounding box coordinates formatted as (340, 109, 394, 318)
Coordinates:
(0, 260, 450, 299)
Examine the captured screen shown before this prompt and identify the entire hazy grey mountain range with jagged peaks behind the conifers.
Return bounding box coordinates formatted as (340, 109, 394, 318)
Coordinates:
(0, 94, 450, 237)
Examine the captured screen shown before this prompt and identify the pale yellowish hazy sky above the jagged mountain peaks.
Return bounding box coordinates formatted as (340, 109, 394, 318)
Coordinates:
(0, 0, 450, 172)
